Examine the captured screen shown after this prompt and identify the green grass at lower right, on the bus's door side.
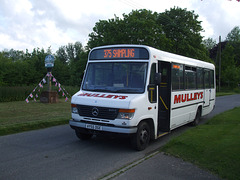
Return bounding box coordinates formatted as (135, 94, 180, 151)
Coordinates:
(161, 107, 240, 180)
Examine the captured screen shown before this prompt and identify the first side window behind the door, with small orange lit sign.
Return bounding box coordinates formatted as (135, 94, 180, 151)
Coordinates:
(172, 64, 184, 90)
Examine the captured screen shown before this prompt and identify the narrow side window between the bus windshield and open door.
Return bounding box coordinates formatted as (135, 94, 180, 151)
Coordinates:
(148, 63, 157, 103)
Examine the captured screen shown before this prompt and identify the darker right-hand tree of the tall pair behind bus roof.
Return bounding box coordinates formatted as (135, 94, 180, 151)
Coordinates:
(158, 7, 210, 61)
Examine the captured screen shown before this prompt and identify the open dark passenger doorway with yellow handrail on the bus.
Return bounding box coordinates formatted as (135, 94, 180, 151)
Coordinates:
(158, 61, 171, 136)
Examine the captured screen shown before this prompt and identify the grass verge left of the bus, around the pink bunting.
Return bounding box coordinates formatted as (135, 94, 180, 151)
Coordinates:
(0, 99, 71, 135)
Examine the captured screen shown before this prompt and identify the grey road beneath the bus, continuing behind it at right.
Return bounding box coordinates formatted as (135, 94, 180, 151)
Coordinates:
(0, 95, 240, 180)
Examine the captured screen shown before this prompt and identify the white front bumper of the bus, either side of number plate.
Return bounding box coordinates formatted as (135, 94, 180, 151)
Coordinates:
(69, 119, 137, 134)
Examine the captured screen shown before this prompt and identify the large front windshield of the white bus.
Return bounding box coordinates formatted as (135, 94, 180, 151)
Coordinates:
(82, 62, 147, 93)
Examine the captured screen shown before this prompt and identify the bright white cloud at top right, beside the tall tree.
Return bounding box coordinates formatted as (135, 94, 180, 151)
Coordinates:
(192, 0, 240, 39)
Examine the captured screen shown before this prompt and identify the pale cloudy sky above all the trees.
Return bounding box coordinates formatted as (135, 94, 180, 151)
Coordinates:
(0, 0, 240, 52)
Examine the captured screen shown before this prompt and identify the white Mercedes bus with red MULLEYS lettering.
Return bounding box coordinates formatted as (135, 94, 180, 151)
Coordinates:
(69, 45, 216, 150)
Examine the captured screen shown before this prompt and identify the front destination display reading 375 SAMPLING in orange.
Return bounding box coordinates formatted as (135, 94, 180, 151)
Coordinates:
(89, 48, 149, 60)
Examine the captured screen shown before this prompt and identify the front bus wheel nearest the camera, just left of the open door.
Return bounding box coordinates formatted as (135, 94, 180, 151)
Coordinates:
(131, 122, 150, 151)
